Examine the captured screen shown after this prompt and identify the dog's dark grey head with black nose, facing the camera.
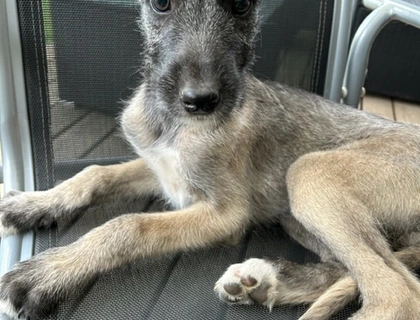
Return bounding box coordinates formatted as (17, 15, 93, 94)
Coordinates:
(140, 0, 259, 124)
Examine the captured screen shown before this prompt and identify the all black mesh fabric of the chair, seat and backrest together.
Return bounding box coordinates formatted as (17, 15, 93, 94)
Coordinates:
(17, 0, 357, 320)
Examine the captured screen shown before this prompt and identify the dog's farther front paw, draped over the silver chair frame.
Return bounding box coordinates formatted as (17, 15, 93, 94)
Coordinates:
(0, 191, 55, 237)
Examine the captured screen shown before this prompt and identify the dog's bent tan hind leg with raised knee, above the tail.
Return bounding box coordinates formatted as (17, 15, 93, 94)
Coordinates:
(287, 151, 420, 320)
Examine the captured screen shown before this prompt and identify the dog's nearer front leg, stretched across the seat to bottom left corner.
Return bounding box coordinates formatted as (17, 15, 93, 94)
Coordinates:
(0, 203, 248, 319)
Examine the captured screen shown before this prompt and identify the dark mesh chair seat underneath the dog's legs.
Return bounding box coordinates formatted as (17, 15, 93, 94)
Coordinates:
(35, 201, 357, 320)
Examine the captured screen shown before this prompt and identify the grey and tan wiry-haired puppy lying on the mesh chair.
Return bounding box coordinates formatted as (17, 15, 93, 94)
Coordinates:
(0, 0, 420, 320)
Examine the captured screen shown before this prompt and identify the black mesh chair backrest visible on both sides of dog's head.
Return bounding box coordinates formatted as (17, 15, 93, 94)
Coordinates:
(17, 0, 334, 190)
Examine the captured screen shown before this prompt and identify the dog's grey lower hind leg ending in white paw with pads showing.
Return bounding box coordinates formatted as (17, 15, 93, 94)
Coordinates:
(214, 258, 347, 309)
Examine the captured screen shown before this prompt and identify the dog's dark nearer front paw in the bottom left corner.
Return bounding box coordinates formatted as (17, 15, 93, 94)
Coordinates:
(0, 248, 78, 320)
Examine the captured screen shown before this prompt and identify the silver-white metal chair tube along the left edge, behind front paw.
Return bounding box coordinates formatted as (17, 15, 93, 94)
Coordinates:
(0, 0, 34, 320)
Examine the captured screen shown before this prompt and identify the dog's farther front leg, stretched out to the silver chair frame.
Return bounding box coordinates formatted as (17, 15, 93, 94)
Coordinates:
(0, 159, 159, 237)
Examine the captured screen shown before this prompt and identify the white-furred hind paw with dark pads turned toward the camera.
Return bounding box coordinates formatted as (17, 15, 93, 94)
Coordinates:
(214, 259, 278, 310)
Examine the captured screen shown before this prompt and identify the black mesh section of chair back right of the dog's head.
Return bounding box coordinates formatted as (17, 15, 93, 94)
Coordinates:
(254, 0, 334, 94)
